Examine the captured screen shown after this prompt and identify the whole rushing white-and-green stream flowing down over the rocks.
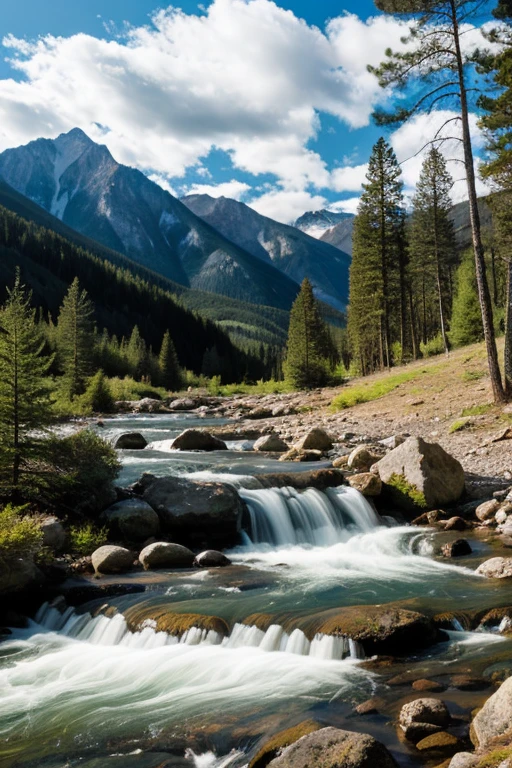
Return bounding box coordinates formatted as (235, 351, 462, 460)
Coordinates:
(0, 414, 512, 768)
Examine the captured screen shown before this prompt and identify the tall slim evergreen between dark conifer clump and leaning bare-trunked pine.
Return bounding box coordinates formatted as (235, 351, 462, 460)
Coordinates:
(410, 147, 456, 352)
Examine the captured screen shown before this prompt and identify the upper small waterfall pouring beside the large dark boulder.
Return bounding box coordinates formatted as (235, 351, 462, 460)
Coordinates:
(239, 486, 382, 547)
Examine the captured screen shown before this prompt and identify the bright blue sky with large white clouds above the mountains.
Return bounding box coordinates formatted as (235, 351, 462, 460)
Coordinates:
(0, 0, 494, 221)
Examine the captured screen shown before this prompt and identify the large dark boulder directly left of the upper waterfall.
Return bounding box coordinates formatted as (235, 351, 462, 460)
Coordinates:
(138, 474, 245, 549)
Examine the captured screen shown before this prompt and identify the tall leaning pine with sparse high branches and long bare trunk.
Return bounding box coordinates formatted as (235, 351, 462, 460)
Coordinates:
(370, 0, 506, 402)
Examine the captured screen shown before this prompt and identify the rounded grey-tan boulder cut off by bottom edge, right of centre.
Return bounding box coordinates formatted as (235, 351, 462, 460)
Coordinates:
(268, 728, 397, 768)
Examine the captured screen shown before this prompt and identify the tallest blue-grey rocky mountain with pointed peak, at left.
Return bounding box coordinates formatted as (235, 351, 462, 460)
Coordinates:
(0, 128, 298, 309)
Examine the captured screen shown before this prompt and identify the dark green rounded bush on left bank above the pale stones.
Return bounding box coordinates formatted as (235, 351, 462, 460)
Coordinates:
(44, 429, 121, 509)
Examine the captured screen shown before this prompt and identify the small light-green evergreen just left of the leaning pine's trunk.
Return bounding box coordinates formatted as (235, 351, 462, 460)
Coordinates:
(450, 254, 484, 347)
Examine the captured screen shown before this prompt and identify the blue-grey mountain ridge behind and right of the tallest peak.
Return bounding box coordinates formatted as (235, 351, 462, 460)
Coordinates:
(182, 195, 350, 311)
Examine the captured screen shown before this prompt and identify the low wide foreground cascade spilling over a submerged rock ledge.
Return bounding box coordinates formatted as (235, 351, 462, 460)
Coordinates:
(35, 603, 365, 661)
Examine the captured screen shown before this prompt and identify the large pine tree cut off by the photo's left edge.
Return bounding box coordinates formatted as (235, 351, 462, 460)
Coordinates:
(0, 270, 52, 500)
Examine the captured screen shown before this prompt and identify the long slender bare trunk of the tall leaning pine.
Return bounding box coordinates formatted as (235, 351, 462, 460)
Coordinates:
(450, 0, 506, 403)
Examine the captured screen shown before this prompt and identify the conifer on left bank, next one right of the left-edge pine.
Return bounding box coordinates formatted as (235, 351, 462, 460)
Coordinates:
(57, 277, 94, 400)
